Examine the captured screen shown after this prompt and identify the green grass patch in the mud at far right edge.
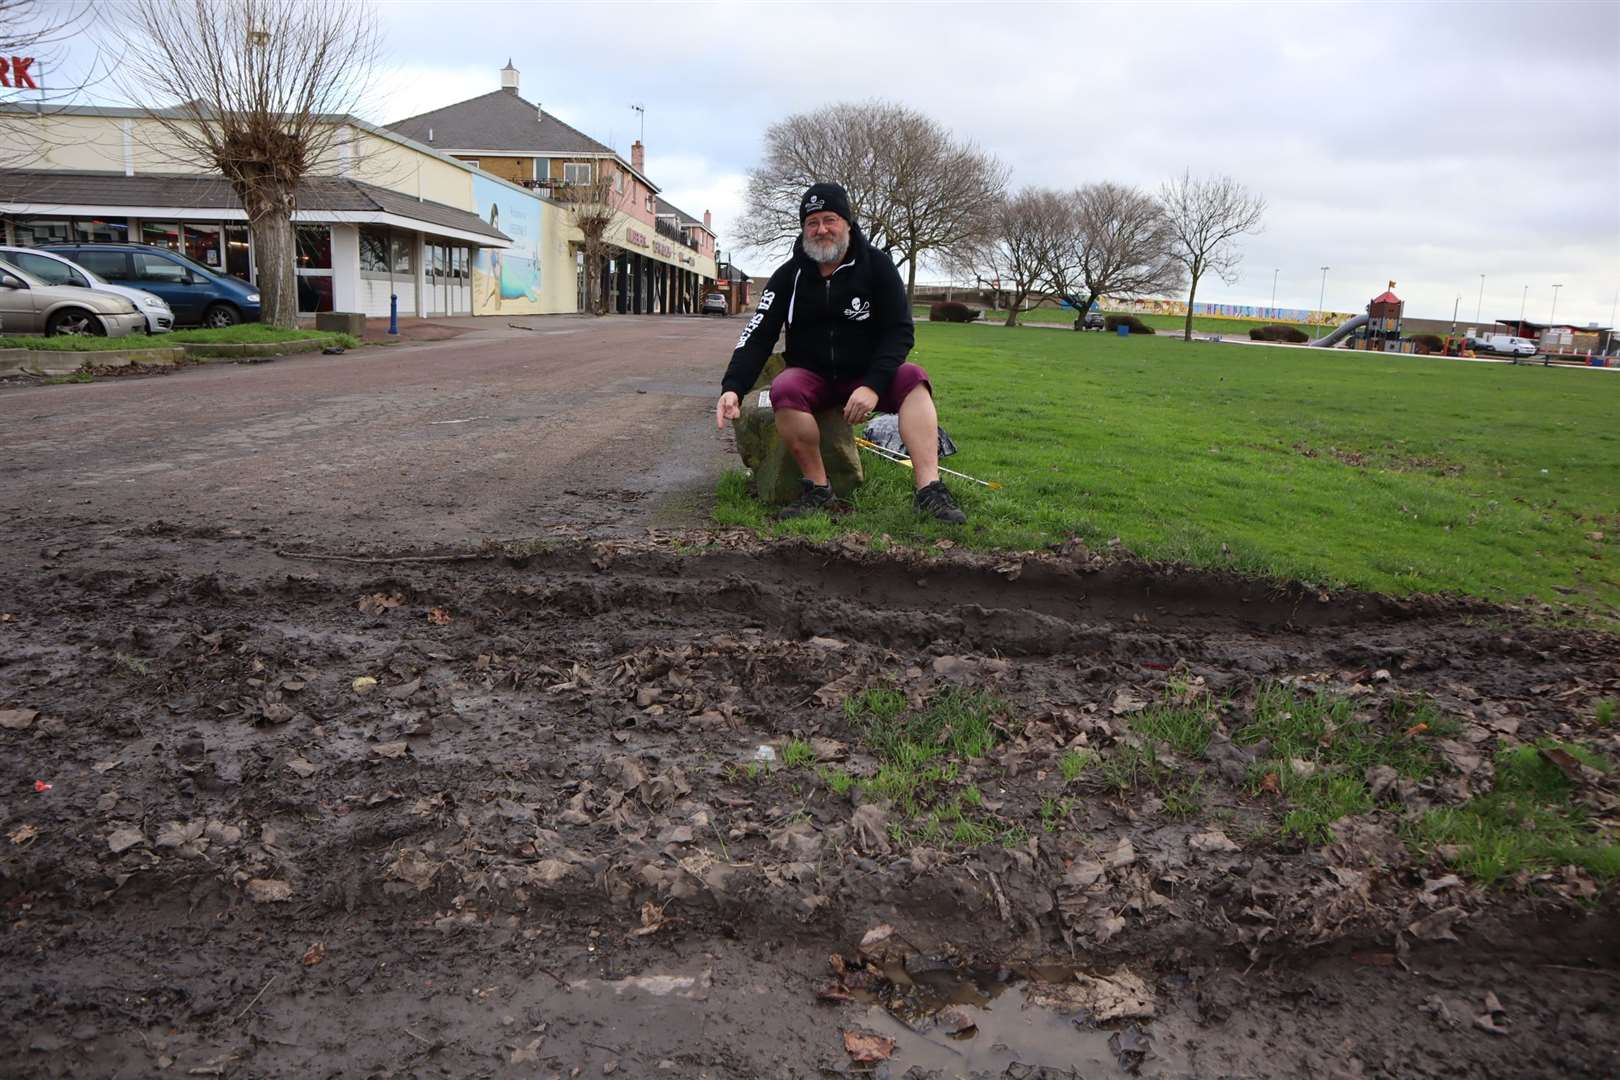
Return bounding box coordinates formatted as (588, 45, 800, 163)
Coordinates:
(1408, 740, 1620, 884)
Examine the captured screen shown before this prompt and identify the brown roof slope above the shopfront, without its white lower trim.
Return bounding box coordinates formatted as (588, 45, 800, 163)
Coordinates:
(0, 168, 510, 240)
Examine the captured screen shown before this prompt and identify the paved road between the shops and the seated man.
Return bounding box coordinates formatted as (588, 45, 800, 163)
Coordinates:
(0, 316, 735, 547)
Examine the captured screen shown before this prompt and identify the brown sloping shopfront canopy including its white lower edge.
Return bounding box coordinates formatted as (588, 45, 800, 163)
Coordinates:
(0, 168, 512, 248)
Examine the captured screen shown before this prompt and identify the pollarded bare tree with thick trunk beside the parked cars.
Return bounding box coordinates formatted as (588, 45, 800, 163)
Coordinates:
(123, 0, 377, 327)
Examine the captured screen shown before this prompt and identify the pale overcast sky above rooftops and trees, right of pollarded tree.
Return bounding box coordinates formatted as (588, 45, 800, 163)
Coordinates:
(50, 0, 1620, 324)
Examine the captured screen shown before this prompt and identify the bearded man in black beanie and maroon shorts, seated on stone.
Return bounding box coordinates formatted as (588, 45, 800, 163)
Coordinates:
(714, 183, 967, 525)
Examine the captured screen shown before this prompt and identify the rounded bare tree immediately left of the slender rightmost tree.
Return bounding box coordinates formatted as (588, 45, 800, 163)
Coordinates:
(1040, 183, 1183, 330)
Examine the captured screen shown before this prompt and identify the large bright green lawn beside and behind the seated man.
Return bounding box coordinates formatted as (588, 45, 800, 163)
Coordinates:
(714, 324, 1620, 627)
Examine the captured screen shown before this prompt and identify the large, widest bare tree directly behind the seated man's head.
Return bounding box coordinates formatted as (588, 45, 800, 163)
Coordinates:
(740, 102, 1006, 298)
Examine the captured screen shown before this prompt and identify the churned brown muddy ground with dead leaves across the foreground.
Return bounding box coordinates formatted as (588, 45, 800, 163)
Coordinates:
(0, 521, 1620, 1080)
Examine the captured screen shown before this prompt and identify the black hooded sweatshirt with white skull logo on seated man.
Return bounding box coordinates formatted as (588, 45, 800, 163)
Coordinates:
(721, 225, 915, 397)
